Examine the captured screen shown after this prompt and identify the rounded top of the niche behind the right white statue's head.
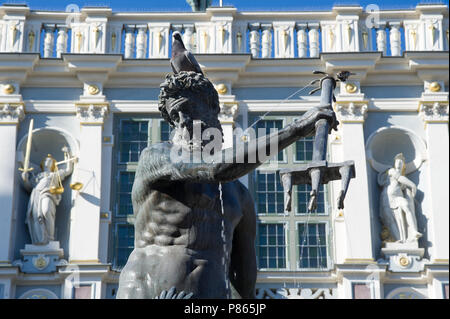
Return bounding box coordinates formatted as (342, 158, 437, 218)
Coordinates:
(366, 126, 427, 175)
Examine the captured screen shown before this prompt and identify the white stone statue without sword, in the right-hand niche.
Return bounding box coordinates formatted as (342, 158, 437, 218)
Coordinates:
(378, 153, 422, 243)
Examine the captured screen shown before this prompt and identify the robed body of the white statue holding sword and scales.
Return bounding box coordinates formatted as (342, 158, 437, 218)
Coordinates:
(22, 147, 73, 245)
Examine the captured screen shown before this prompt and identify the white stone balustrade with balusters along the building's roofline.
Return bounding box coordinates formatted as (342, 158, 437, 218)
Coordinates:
(0, 5, 449, 59)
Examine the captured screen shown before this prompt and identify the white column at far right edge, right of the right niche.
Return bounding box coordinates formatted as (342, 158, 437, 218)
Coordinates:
(419, 99, 449, 265)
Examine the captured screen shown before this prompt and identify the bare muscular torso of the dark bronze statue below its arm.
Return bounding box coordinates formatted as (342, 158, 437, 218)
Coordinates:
(117, 144, 254, 298)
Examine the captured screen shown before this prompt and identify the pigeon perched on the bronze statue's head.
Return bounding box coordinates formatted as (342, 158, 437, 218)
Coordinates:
(170, 31, 204, 75)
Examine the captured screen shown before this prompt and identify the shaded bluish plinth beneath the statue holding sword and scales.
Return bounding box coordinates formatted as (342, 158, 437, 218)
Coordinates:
(13, 241, 67, 274)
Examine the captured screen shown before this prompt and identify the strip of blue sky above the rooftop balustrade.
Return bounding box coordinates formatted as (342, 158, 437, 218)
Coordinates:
(0, 0, 448, 11)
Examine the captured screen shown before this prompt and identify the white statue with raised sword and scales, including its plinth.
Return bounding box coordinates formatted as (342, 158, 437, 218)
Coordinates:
(15, 119, 83, 273)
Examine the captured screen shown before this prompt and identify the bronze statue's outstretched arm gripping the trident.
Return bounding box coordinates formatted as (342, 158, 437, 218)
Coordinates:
(136, 108, 337, 188)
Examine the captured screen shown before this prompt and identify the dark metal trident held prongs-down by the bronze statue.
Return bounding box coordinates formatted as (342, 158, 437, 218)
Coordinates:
(280, 71, 355, 212)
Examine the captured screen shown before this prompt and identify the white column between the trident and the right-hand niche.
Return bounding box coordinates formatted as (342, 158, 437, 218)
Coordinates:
(336, 100, 374, 264)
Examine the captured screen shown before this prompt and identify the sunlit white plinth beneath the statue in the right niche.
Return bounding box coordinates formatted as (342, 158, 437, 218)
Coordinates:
(381, 241, 425, 272)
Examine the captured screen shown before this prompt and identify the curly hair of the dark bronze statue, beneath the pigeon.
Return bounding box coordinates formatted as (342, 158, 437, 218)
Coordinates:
(158, 71, 220, 127)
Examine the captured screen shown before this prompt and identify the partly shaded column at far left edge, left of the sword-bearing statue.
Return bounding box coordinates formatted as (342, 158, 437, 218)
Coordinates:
(0, 102, 24, 265)
